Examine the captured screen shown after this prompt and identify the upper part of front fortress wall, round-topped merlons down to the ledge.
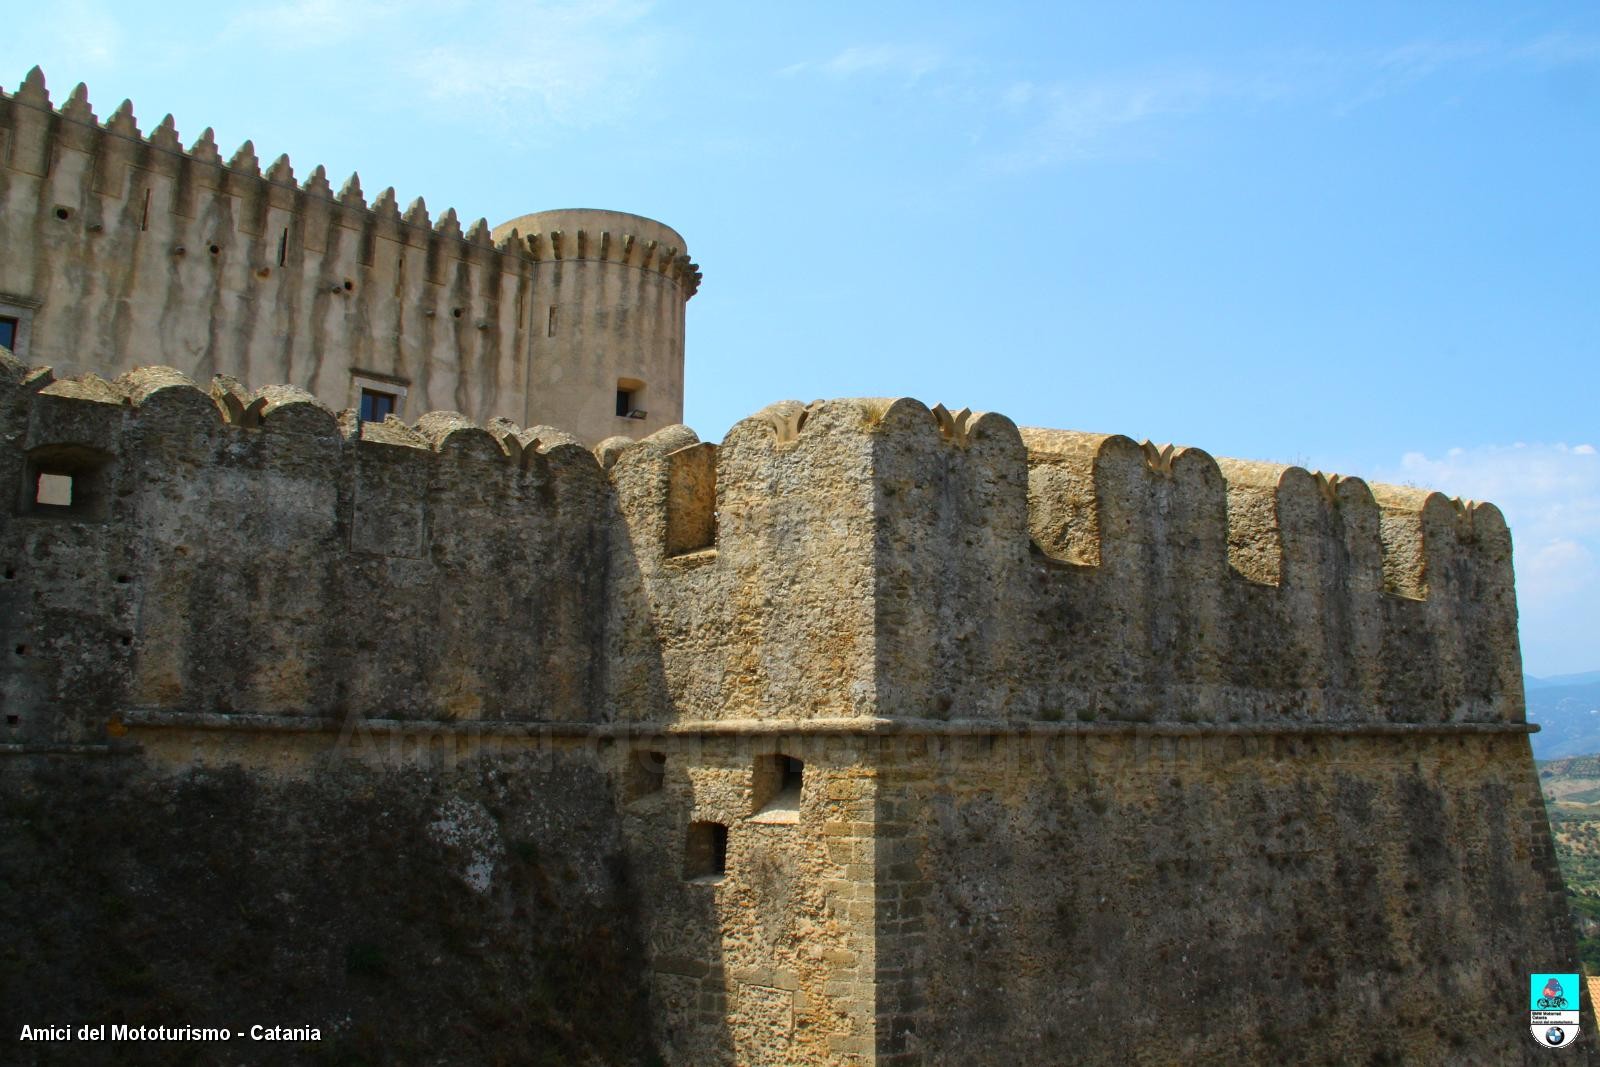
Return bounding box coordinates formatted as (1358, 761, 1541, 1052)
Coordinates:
(0, 357, 1523, 733)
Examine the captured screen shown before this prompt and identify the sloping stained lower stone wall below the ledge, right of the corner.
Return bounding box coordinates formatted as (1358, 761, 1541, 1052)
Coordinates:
(875, 734, 1576, 1064)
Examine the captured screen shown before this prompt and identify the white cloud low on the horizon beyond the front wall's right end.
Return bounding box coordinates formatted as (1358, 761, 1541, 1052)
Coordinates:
(1379, 442, 1600, 675)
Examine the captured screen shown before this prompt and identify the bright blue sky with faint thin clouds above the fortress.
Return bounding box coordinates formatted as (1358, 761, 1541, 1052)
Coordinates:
(0, 0, 1600, 675)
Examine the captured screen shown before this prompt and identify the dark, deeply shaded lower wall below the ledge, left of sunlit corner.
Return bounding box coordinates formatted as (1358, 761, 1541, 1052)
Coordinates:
(0, 731, 653, 1067)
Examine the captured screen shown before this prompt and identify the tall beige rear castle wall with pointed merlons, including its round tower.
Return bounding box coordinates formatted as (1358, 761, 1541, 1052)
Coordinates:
(0, 69, 699, 443)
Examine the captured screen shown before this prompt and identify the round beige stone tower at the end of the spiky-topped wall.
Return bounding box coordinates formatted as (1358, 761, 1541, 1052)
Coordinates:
(493, 208, 701, 445)
